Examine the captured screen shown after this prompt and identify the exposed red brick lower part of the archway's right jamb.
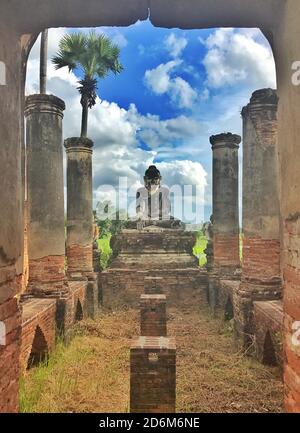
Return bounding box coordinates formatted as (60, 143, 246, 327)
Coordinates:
(283, 215, 300, 412)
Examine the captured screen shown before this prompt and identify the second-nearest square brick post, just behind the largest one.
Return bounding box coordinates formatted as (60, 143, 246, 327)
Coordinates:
(140, 295, 167, 337)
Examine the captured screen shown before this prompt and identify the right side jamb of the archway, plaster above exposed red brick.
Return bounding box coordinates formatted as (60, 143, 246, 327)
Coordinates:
(274, 0, 300, 412)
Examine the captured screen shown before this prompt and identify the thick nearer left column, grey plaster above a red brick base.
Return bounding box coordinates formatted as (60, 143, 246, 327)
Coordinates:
(25, 95, 67, 297)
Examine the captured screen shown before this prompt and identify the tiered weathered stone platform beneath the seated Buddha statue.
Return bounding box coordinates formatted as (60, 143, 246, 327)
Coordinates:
(101, 227, 207, 308)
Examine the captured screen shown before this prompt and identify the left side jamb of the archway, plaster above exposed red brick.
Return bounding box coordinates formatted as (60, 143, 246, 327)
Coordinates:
(0, 22, 23, 412)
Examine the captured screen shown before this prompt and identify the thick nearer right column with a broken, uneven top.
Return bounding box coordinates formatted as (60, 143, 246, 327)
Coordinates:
(234, 89, 282, 346)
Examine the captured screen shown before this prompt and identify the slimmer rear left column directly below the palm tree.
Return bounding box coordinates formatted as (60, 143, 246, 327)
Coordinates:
(65, 137, 93, 278)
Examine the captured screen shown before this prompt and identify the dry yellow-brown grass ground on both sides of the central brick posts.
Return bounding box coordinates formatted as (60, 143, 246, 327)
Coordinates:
(21, 294, 283, 413)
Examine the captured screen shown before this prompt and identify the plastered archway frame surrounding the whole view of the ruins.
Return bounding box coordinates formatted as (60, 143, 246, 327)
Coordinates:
(0, 0, 300, 411)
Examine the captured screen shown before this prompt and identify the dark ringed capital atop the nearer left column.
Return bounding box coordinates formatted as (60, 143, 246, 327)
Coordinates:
(25, 94, 66, 118)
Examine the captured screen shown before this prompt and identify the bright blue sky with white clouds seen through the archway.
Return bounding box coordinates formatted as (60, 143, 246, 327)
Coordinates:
(27, 21, 276, 223)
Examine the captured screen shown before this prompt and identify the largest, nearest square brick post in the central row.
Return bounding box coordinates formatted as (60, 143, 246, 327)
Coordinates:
(130, 337, 176, 413)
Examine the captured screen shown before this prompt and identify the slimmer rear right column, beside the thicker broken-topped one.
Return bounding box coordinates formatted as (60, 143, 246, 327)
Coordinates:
(210, 133, 241, 274)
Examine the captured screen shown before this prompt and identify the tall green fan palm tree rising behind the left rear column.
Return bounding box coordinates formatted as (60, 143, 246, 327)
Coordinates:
(52, 31, 123, 137)
